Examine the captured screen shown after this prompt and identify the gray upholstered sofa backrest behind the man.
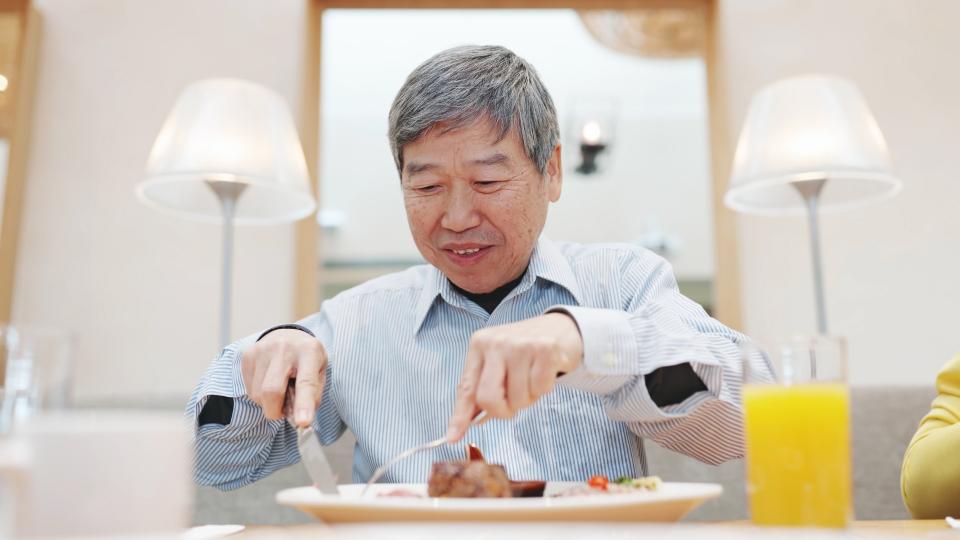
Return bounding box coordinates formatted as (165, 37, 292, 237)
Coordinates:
(194, 387, 934, 524)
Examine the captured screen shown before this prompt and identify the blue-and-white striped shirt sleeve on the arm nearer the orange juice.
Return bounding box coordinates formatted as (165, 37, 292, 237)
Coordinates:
(548, 251, 770, 464)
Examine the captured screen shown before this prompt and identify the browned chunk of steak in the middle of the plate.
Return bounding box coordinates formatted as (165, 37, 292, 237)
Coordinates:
(427, 461, 510, 497)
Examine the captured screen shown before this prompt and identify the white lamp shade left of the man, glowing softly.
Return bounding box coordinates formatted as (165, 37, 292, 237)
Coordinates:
(137, 79, 316, 224)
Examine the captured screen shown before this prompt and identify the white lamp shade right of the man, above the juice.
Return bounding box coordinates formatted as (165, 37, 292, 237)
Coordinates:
(724, 75, 901, 215)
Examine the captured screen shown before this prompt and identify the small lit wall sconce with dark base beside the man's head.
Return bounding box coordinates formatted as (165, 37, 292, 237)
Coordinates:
(569, 99, 616, 175)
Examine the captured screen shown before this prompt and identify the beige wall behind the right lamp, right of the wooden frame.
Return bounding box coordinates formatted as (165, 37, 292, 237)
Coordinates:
(718, 0, 960, 385)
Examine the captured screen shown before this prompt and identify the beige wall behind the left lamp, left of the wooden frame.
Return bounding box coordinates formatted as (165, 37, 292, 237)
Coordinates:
(13, 0, 304, 401)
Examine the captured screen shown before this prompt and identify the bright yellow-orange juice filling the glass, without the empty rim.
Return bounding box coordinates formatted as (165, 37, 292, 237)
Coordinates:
(743, 383, 851, 527)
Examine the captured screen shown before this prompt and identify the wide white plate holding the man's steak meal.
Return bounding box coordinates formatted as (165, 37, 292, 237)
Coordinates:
(277, 482, 723, 523)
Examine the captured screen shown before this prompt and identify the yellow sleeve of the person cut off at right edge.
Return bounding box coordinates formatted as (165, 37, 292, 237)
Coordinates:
(900, 355, 960, 519)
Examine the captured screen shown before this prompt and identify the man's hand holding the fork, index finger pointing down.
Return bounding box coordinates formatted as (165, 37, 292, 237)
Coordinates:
(447, 313, 583, 442)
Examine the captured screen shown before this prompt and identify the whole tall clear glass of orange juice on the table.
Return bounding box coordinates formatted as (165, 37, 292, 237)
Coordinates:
(743, 336, 852, 527)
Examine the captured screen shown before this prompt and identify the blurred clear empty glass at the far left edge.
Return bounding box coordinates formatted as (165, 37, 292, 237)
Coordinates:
(0, 326, 73, 434)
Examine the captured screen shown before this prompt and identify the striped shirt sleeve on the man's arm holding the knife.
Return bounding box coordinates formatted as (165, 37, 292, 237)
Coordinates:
(186, 310, 345, 490)
